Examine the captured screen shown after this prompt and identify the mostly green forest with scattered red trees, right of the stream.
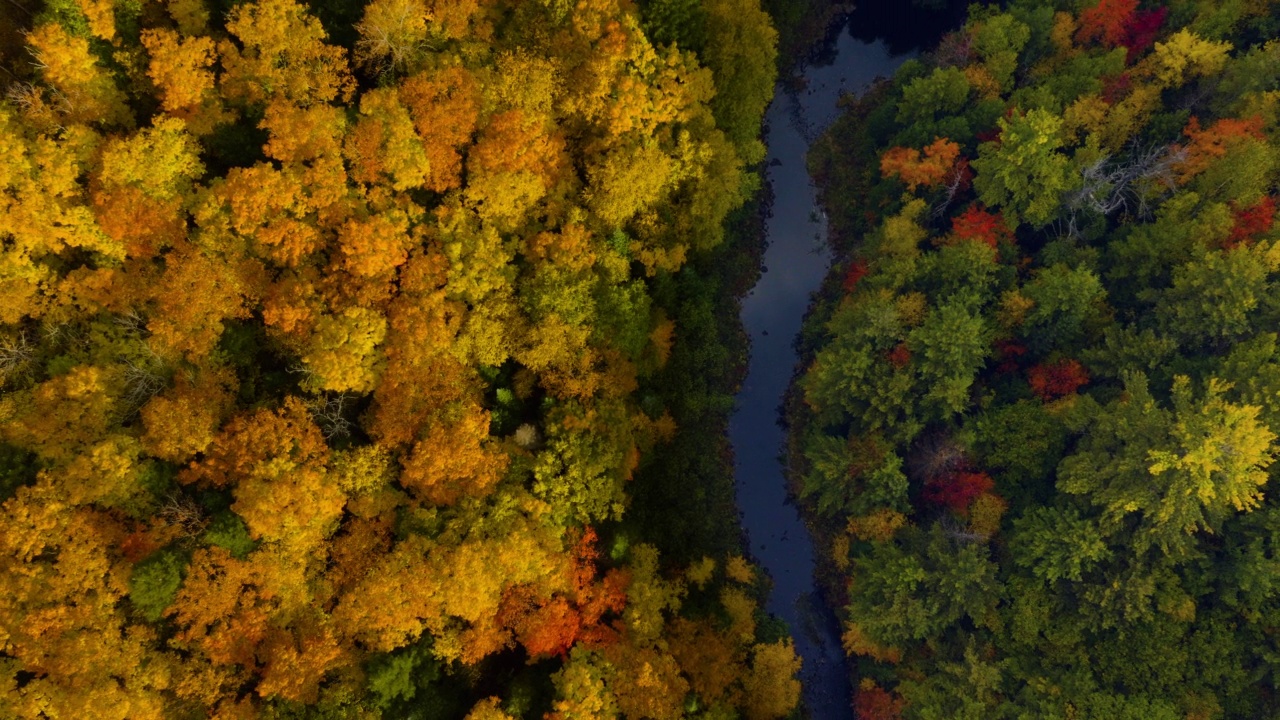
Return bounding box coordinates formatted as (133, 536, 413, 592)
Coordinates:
(794, 0, 1280, 720)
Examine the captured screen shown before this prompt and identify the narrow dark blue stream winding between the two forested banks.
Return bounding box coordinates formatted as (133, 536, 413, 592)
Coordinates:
(730, 32, 909, 720)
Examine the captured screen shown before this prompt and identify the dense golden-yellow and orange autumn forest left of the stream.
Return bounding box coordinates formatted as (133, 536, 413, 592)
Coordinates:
(0, 0, 798, 720)
